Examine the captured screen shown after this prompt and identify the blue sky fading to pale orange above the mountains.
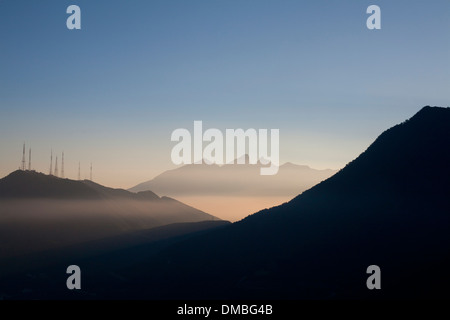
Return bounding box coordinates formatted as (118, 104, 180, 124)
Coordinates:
(0, 0, 450, 188)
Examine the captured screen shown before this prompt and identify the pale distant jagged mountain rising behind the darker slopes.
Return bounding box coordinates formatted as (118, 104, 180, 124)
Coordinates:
(129, 159, 336, 197)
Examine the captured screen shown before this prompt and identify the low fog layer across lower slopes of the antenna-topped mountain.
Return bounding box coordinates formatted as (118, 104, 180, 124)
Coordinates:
(0, 198, 217, 260)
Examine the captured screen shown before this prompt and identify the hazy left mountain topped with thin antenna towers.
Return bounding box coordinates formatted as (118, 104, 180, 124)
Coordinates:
(0, 171, 220, 258)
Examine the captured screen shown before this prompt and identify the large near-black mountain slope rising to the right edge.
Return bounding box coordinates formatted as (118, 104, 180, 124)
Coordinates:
(2, 107, 450, 299)
